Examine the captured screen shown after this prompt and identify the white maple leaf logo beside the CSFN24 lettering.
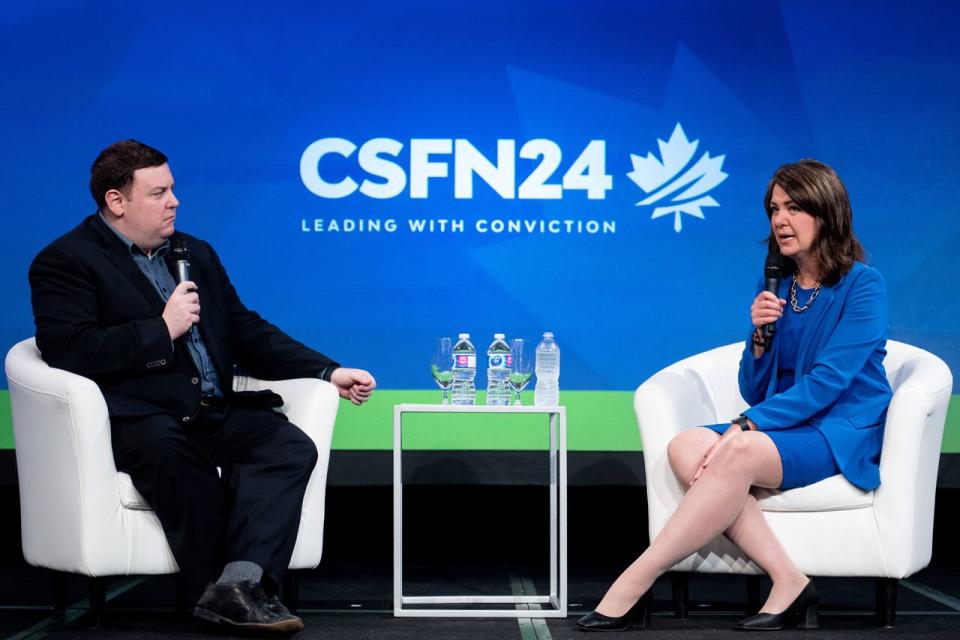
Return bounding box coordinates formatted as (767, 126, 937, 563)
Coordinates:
(627, 122, 727, 233)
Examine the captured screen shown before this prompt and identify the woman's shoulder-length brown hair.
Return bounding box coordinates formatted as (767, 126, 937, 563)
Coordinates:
(763, 160, 865, 286)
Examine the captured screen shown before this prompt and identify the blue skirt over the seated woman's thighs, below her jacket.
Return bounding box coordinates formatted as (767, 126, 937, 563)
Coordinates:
(704, 422, 840, 490)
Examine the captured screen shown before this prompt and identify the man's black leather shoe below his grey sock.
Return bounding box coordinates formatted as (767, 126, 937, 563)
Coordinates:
(193, 580, 303, 635)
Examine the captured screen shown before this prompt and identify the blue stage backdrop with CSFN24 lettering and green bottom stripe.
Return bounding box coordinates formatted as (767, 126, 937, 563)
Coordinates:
(0, 0, 960, 451)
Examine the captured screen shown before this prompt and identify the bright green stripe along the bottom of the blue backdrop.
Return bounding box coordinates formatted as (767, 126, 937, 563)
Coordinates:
(0, 389, 960, 453)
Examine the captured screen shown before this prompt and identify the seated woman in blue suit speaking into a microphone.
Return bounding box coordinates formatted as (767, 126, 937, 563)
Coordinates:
(577, 160, 892, 631)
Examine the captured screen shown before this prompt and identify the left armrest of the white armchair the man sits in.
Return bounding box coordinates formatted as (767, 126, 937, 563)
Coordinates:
(6, 339, 121, 573)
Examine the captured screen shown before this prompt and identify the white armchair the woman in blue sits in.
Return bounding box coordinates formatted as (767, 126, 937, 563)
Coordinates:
(634, 340, 953, 626)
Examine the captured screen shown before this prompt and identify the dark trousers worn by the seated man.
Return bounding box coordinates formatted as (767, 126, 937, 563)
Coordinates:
(111, 406, 317, 602)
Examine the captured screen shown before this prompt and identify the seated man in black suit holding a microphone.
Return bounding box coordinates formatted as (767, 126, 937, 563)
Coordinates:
(30, 140, 376, 633)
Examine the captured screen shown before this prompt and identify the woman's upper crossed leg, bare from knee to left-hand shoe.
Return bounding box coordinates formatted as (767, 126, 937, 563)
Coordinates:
(597, 431, 783, 617)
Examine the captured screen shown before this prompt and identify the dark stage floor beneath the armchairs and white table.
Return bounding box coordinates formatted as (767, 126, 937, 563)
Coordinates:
(0, 567, 960, 640)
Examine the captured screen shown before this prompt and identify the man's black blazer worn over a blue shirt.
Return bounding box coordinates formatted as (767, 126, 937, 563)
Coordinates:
(30, 213, 338, 419)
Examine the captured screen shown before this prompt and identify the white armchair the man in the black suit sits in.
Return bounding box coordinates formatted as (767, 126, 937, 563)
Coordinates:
(6, 338, 339, 606)
